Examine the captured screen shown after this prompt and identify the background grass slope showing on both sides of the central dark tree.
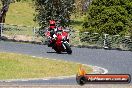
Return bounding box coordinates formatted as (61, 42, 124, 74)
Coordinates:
(6, 2, 84, 30)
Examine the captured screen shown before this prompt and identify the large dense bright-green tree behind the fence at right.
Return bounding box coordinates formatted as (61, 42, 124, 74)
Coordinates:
(83, 0, 132, 35)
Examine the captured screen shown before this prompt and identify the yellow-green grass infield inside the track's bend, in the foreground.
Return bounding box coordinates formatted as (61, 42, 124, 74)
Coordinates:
(0, 53, 92, 80)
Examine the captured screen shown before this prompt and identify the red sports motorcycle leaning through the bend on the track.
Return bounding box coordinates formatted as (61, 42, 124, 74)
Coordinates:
(45, 28, 72, 54)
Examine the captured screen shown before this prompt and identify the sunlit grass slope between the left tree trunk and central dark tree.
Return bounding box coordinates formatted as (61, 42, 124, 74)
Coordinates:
(5, 2, 36, 26)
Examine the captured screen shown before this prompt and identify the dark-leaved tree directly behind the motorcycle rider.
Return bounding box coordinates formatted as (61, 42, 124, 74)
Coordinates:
(34, 0, 74, 28)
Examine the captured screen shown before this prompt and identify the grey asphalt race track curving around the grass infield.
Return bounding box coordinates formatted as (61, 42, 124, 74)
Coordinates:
(0, 41, 132, 85)
